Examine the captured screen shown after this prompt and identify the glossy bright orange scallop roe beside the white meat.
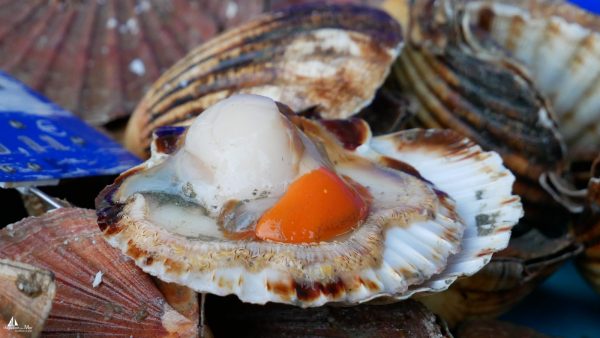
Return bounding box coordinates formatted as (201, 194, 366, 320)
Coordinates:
(255, 168, 369, 243)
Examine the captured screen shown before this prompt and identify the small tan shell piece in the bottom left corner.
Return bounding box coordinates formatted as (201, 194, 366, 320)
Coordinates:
(0, 259, 56, 337)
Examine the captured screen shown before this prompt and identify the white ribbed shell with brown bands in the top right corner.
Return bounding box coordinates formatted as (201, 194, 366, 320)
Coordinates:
(460, 0, 600, 151)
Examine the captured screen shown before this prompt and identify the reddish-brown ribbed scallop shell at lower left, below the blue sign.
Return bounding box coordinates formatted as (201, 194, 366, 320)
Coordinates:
(0, 208, 196, 337)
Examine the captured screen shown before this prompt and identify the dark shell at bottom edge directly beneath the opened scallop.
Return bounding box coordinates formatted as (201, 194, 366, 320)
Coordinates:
(206, 296, 452, 338)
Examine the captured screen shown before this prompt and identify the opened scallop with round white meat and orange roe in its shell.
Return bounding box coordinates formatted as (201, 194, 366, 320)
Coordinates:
(96, 95, 522, 307)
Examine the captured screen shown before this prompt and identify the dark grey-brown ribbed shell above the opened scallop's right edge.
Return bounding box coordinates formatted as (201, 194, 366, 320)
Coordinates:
(394, 37, 564, 181)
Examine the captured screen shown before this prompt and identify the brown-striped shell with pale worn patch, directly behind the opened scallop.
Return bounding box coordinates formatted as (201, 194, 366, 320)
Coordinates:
(125, 4, 402, 156)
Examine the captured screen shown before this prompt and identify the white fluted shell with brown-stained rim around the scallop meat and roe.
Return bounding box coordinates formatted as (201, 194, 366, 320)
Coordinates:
(96, 105, 522, 307)
